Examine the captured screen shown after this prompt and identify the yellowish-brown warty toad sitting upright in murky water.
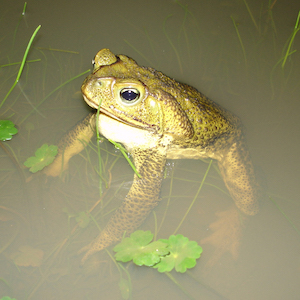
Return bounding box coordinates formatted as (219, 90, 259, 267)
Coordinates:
(45, 49, 258, 262)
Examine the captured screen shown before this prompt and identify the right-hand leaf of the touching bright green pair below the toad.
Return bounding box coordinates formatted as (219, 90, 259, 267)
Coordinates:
(154, 234, 202, 273)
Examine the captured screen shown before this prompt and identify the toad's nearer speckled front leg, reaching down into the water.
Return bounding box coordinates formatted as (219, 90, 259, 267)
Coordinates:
(79, 149, 166, 263)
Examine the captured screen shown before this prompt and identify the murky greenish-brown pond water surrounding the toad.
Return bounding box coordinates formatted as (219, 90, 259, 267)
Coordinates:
(0, 0, 300, 300)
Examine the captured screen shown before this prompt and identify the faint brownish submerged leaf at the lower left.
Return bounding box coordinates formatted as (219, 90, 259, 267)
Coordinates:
(10, 245, 44, 267)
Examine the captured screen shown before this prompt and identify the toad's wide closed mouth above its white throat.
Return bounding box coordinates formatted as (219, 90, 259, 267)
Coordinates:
(83, 94, 157, 131)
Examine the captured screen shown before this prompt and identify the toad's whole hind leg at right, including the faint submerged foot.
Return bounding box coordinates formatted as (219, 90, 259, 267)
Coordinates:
(201, 139, 259, 267)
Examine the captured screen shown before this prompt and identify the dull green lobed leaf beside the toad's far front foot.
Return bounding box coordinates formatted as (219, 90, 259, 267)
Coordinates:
(24, 144, 58, 173)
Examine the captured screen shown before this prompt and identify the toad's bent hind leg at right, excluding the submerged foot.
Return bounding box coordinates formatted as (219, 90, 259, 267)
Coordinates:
(218, 138, 259, 215)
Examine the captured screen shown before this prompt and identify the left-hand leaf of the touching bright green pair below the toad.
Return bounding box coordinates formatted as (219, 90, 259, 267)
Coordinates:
(113, 230, 169, 267)
